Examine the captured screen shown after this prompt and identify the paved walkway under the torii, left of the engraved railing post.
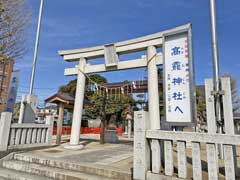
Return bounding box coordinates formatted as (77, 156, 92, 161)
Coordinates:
(23, 134, 133, 171)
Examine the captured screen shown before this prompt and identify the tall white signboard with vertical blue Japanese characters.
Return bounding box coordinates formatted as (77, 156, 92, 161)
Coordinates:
(164, 31, 194, 123)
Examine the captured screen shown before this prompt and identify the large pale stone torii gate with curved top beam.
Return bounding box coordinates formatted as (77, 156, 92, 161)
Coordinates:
(59, 24, 191, 148)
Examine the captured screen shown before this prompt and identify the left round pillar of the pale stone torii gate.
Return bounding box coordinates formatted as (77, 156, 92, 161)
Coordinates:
(70, 58, 86, 146)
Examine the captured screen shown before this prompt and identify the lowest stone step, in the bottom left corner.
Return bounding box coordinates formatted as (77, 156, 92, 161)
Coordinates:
(0, 167, 53, 180)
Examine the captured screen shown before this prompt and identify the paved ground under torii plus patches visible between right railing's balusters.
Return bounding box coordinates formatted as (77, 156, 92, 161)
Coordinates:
(3, 134, 240, 179)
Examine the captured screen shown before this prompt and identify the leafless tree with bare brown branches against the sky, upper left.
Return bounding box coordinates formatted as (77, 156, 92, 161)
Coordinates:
(0, 0, 30, 62)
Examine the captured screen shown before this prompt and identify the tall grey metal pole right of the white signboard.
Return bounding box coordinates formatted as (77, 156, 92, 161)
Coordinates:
(210, 0, 223, 158)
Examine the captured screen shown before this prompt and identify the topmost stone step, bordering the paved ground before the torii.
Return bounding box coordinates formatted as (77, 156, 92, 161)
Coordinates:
(14, 153, 132, 180)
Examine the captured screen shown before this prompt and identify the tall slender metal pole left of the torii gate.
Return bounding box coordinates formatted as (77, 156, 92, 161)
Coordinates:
(29, 0, 44, 95)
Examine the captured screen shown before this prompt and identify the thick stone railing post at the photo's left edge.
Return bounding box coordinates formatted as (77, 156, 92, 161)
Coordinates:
(0, 112, 12, 151)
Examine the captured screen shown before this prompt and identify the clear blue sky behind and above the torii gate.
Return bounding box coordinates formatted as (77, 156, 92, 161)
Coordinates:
(15, 0, 240, 104)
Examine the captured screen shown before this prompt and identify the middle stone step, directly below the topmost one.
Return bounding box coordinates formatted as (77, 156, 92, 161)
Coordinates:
(3, 160, 120, 180)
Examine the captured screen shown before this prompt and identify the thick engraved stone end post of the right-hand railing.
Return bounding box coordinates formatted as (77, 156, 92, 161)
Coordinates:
(133, 111, 150, 180)
